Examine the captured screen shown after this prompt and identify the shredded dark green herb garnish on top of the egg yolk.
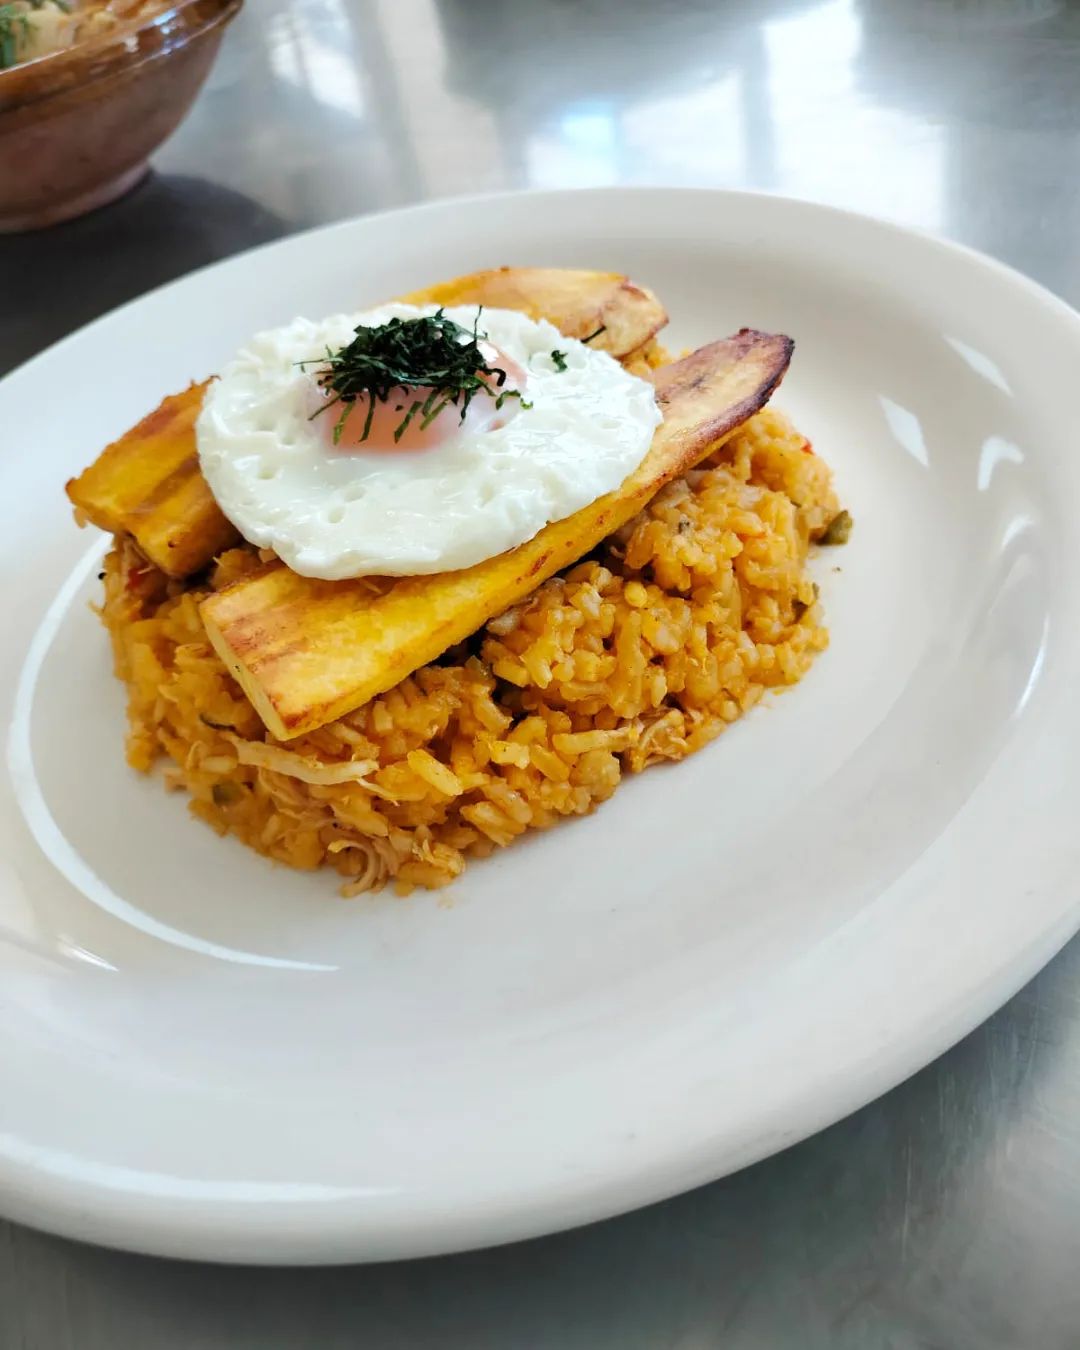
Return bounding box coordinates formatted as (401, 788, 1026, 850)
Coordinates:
(300, 309, 532, 446)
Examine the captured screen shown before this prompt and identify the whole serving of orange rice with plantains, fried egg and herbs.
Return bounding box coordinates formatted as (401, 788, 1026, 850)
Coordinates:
(68, 269, 851, 894)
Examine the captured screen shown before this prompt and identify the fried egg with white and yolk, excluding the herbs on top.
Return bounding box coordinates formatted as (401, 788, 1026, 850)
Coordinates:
(196, 305, 660, 581)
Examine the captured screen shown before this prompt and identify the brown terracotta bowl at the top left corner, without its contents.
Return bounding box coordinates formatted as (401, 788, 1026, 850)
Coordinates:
(0, 0, 243, 234)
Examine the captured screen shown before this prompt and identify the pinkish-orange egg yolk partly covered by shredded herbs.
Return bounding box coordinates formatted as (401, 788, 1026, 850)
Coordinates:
(309, 342, 528, 455)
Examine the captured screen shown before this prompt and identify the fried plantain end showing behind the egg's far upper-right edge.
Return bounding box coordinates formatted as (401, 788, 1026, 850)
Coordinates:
(401, 267, 667, 359)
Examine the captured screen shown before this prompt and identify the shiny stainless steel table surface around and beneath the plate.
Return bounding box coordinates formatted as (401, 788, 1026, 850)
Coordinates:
(0, 0, 1080, 1350)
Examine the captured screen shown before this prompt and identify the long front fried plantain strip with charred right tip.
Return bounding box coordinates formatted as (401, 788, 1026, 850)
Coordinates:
(200, 329, 794, 740)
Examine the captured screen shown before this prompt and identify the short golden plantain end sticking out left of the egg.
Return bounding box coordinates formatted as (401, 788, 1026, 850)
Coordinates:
(66, 383, 240, 576)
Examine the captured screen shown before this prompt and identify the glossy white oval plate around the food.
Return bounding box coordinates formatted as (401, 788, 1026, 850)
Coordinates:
(0, 190, 1080, 1261)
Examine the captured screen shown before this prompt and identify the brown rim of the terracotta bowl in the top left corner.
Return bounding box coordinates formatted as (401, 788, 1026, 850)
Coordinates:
(0, 0, 243, 116)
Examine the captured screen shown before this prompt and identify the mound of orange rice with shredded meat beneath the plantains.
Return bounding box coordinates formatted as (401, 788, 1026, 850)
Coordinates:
(101, 408, 837, 895)
